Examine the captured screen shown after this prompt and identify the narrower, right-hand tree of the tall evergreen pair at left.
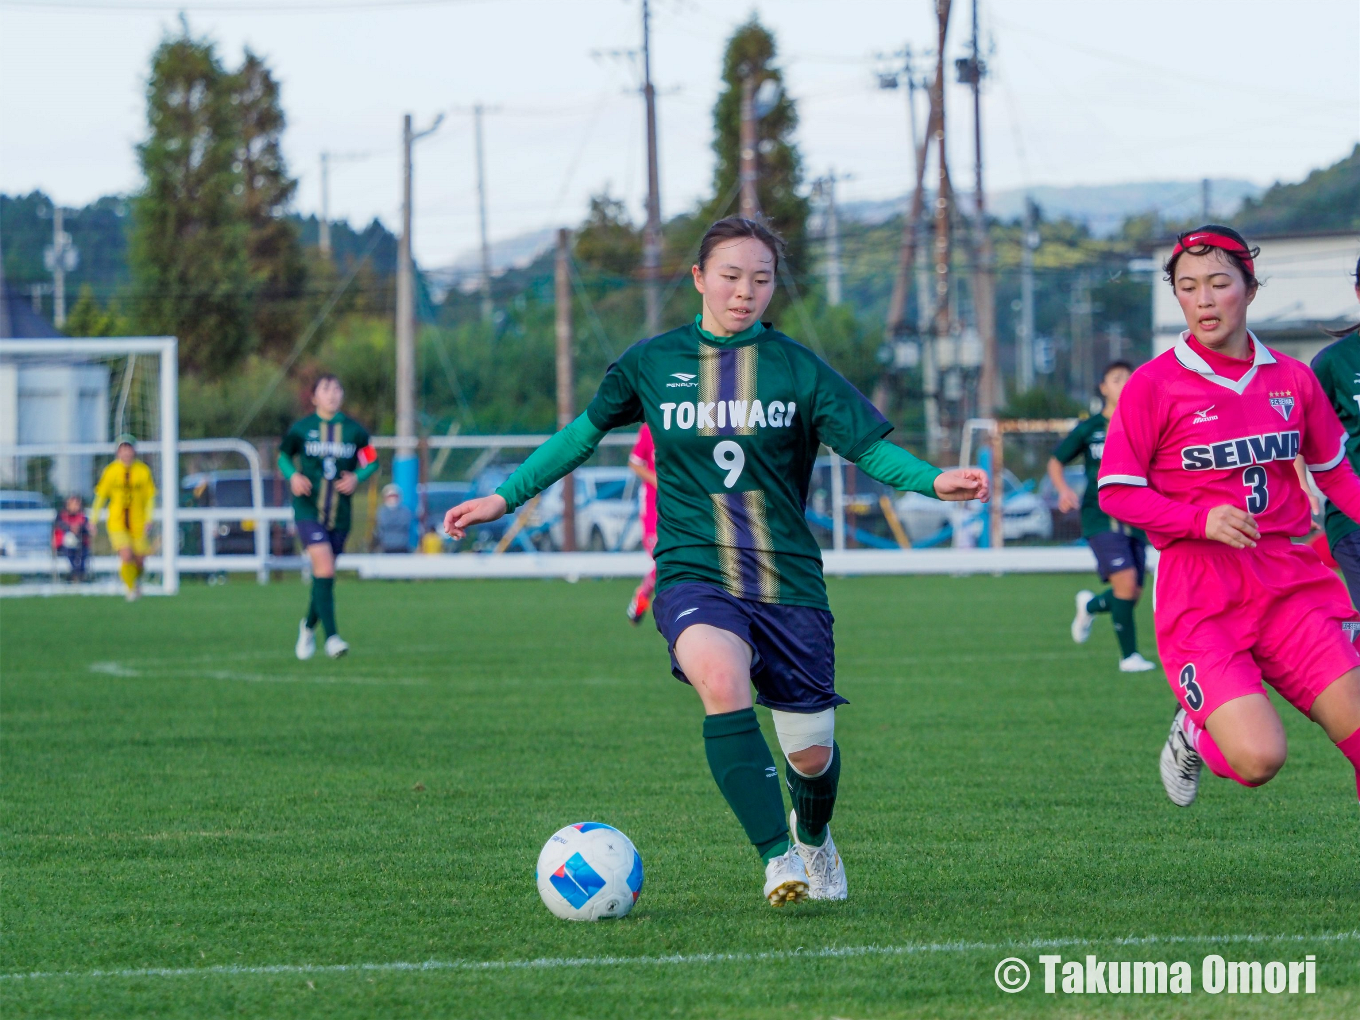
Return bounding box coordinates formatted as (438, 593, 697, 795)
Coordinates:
(226, 49, 307, 364)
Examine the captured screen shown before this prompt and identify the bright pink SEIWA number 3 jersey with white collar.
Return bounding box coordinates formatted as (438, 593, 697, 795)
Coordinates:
(1100, 332, 1360, 549)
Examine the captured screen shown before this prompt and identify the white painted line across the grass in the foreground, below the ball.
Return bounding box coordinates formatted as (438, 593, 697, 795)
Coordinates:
(0, 932, 1360, 981)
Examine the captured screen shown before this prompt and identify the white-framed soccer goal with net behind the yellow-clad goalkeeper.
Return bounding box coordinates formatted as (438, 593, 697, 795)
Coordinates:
(0, 337, 180, 594)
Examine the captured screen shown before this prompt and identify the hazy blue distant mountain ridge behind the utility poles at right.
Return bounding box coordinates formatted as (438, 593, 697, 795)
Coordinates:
(842, 177, 1262, 237)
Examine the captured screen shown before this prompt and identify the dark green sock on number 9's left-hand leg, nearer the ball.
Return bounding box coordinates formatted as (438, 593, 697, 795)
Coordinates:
(703, 709, 794, 864)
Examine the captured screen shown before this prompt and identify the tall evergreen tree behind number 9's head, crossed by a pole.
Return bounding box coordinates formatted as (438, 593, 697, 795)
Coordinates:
(704, 15, 808, 265)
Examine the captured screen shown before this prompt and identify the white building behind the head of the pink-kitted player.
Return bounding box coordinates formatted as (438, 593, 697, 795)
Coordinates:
(1152, 230, 1360, 362)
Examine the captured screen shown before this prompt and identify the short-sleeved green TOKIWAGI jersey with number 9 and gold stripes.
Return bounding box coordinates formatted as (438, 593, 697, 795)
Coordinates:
(586, 315, 892, 609)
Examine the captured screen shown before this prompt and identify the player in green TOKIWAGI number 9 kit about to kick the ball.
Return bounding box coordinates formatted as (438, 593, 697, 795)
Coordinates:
(445, 216, 987, 907)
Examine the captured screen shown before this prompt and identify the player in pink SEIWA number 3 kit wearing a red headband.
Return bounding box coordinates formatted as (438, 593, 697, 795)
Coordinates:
(1100, 224, 1360, 806)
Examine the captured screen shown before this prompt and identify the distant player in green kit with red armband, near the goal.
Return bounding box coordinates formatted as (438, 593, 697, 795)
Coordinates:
(279, 374, 378, 658)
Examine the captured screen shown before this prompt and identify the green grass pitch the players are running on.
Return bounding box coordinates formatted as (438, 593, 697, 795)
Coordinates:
(0, 577, 1360, 1019)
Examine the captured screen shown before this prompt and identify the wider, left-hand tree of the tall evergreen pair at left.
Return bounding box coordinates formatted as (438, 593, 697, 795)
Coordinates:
(129, 23, 254, 374)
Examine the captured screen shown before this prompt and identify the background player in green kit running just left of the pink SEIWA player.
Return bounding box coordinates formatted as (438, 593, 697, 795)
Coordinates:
(1049, 362, 1156, 673)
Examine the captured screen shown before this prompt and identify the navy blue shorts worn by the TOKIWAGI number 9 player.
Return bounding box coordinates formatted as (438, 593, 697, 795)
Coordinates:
(651, 581, 846, 713)
